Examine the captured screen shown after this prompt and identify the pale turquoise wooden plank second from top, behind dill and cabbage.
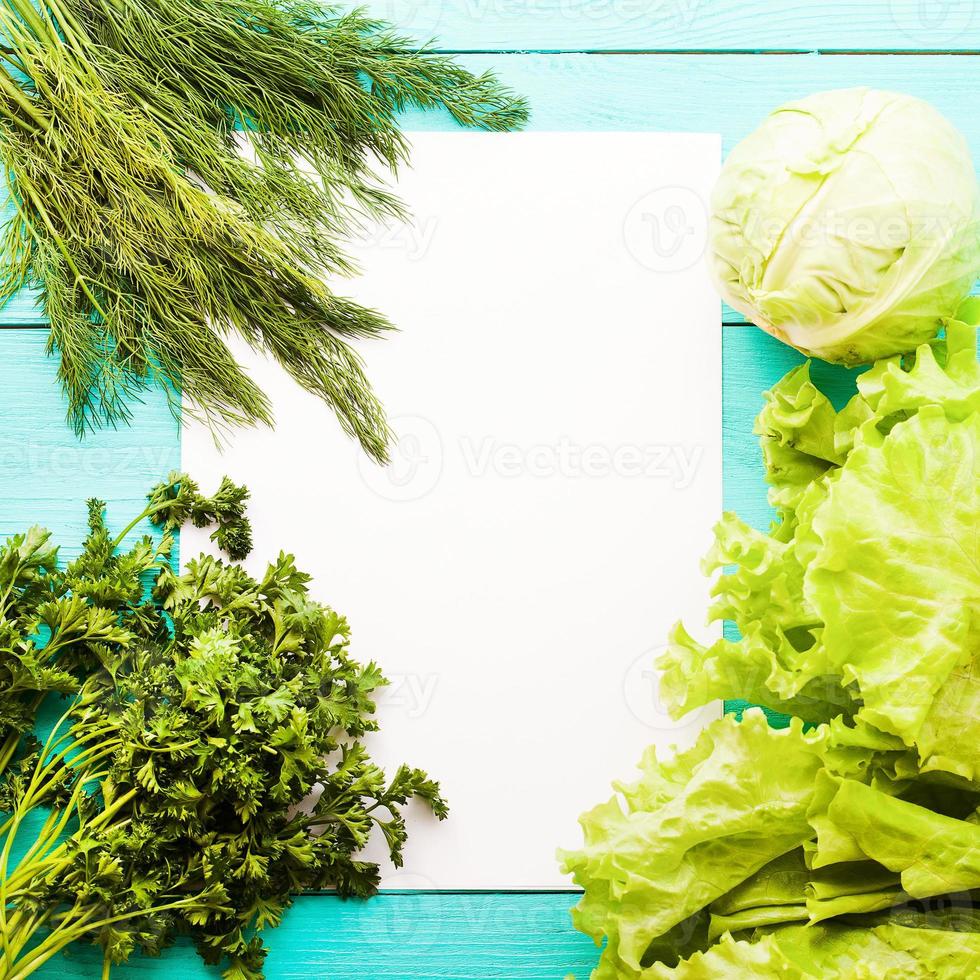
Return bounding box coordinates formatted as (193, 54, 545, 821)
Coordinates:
(7, 54, 980, 325)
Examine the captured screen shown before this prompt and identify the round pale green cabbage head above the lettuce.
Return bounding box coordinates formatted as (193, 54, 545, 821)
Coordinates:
(709, 88, 980, 364)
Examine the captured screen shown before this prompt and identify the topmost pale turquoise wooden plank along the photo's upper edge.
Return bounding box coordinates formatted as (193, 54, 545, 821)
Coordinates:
(368, 0, 980, 51)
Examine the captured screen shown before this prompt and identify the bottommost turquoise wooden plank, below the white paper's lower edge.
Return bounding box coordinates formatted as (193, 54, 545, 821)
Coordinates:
(34, 892, 598, 980)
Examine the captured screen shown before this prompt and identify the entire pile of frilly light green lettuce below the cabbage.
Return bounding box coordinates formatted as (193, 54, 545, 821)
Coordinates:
(561, 300, 980, 980)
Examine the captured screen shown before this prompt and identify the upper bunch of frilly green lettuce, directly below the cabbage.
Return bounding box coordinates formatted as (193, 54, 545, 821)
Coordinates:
(661, 300, 980, 779)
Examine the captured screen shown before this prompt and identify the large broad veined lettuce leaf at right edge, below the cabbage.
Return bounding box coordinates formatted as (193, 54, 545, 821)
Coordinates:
(804, 405, 980, 762)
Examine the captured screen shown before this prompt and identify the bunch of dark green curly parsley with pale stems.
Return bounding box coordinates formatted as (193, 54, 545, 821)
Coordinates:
(0, 475, 446, 980)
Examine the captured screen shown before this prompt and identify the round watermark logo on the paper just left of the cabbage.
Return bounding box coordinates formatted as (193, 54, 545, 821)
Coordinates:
(623, 186, 708, 272)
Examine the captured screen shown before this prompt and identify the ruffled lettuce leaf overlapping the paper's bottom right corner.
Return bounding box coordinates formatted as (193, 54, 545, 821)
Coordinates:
(560, 711, 823, 976)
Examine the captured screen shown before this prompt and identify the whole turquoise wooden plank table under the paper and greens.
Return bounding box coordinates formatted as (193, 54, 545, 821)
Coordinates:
(0, 0, 980, 980)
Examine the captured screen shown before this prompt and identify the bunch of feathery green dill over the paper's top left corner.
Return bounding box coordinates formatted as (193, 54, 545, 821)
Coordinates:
(0, 0, 527, 461)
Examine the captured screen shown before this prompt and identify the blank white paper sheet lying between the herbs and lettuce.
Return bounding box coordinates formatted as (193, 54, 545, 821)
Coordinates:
(182, 133, 721, 888)
